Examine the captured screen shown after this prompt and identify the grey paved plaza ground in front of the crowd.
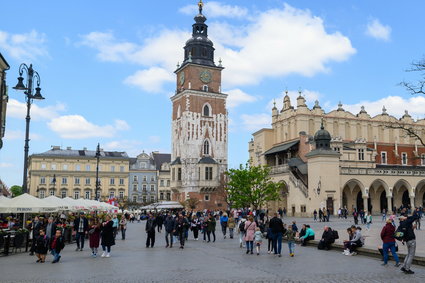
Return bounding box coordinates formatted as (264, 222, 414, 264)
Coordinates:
(0, 222, 425, 283)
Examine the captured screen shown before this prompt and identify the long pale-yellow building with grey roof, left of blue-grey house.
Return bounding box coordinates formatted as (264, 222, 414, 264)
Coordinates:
(28, 146, 130, 200)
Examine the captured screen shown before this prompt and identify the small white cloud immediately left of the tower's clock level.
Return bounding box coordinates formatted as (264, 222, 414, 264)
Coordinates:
(124, 67, 175, 92)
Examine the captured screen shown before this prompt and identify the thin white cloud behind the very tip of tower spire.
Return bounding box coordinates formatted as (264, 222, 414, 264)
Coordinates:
(179, 1, 248, 18)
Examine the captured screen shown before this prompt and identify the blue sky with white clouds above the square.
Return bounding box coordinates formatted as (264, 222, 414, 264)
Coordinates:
(0, 0, 425, 189)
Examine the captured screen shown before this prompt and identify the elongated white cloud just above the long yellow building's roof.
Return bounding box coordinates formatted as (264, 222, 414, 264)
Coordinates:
(48, 115, 129, 139)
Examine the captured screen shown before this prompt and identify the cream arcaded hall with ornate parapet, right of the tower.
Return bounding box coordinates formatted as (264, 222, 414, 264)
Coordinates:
(249, 93, 425, 216)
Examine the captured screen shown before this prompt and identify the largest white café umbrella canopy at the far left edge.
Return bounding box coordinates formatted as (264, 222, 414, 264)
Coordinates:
(0, 194, 59, 213)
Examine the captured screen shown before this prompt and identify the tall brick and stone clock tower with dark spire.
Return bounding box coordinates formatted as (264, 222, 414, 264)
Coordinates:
(170, 1, 228, 209)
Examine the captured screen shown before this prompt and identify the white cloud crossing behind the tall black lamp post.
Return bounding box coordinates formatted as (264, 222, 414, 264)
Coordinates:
(6, 99, 66, 120)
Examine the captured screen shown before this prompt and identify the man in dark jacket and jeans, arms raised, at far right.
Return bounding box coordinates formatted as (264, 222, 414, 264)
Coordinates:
(400, 214, 419, 274)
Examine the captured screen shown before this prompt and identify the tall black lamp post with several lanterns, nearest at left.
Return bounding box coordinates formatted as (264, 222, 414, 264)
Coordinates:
(13, 63, 44, 193)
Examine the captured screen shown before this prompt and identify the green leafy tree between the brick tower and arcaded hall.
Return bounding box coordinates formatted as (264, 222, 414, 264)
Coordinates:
(226, 164, 283, 209)
